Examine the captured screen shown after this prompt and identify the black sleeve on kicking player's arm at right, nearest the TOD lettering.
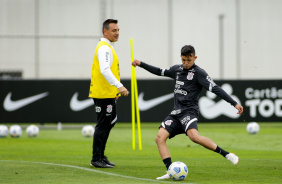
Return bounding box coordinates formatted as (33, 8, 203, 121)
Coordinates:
(198, 70, 237, 106)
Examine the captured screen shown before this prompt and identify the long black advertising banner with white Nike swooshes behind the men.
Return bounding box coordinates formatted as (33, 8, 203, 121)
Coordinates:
(0, 79, 282, 123)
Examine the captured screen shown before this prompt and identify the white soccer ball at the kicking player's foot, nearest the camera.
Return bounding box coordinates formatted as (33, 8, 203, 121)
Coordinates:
(167, 161, 188, 181)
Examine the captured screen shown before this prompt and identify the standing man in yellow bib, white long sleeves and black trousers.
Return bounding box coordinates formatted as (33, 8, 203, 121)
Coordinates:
(89, 19, 129, 168)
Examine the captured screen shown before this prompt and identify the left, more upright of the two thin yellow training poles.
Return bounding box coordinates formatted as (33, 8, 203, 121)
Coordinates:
(130, 39, 135, 150)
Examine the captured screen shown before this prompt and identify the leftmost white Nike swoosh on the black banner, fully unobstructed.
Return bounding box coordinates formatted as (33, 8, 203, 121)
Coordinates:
(3, 92, 48, 111)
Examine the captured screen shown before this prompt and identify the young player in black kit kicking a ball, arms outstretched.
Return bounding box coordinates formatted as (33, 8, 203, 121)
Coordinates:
(132, 45, 243, 179)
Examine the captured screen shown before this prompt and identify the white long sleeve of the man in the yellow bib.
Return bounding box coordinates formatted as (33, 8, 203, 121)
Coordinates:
(97, 45, 123, 88)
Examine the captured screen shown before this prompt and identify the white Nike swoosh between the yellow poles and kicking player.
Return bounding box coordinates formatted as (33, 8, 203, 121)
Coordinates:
(138, 92, 174, 111)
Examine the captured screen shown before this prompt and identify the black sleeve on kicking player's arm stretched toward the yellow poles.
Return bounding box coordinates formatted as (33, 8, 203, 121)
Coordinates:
(140, 61, 177, 78)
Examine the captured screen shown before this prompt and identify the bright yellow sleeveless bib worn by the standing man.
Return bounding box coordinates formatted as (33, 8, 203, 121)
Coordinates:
(89, 41, 120, 98)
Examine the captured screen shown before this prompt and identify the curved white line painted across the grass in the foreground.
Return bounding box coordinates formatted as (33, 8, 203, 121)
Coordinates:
(0, 160, 193, 184)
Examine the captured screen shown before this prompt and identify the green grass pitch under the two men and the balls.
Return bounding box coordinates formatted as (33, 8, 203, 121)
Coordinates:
(0, 123, 282, 184)
